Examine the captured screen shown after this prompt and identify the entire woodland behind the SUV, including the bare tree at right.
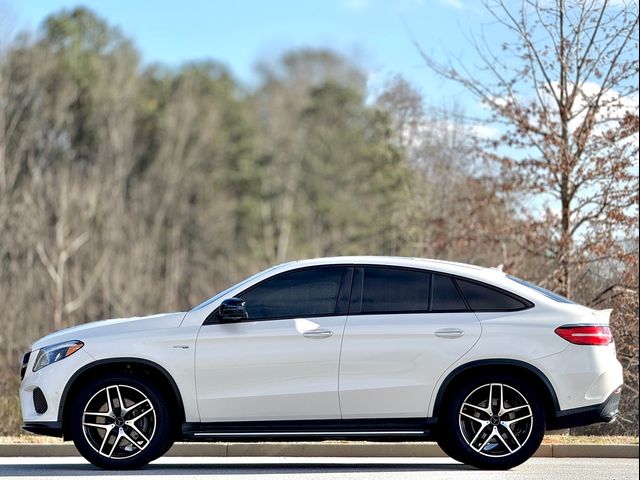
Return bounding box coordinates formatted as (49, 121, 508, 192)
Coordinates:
(0, 0, 638, 435)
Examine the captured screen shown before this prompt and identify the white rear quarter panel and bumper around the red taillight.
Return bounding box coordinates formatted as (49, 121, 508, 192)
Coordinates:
(429, 300, 622, 416)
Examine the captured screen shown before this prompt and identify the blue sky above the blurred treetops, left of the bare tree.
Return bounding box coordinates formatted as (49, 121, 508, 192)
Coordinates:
(0, 0, 496, 104)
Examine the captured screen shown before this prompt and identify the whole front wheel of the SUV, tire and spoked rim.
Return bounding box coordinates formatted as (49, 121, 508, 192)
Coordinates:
(67, 374, 173, 470)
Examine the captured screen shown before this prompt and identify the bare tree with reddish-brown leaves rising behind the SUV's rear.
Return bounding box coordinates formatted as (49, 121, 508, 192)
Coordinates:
(423, 0, 638, 296)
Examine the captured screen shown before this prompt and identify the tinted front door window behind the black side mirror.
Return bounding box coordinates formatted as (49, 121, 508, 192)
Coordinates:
(241, 267, 343, 320)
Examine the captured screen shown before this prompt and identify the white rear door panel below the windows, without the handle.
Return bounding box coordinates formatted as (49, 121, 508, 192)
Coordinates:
(340, 313, 480, 418)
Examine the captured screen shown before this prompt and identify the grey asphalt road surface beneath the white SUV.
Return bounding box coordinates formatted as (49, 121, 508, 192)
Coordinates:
(0, 457, 638, 480)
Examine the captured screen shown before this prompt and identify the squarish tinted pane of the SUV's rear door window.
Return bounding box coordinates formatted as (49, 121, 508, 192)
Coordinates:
(361, 267, 429, 313)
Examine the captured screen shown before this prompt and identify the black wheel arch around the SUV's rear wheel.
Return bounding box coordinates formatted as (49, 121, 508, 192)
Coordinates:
(432, 358, 560, 423)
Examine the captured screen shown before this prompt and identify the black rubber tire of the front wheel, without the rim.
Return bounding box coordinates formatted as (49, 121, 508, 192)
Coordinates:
(68, 374, 172, 470)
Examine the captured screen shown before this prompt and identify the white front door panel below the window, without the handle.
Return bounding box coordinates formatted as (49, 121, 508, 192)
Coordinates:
(196, 316, 346, 422)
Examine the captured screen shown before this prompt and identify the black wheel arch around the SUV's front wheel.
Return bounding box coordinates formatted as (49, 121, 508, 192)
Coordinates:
(58, 357, 185, 438)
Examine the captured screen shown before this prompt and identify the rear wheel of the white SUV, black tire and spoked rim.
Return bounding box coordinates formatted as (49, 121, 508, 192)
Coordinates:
(438, 375, 545, 470)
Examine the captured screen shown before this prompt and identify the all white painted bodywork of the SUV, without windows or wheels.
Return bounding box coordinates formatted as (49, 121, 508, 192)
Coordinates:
(20, 257, 622, 436)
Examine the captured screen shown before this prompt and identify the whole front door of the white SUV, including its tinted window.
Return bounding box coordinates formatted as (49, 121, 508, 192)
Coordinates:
(195, 266, 352, 422)
